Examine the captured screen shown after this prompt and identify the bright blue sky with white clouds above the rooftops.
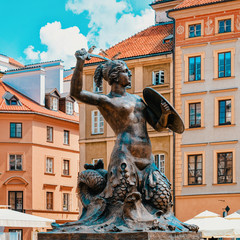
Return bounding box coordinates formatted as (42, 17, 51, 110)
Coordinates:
(0, 0, 154, 68)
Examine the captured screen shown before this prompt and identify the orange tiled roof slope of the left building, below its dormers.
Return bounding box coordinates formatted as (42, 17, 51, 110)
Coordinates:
(0, 80, 79, 123)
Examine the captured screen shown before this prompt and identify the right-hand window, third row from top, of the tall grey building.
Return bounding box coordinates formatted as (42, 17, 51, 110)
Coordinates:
(218, 100, 232, 125)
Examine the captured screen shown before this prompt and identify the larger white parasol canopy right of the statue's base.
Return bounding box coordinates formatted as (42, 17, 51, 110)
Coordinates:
(185, 211, 240, 238)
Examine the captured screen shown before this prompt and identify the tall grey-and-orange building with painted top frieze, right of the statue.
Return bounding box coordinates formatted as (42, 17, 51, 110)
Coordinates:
(169, 0, 240, 221)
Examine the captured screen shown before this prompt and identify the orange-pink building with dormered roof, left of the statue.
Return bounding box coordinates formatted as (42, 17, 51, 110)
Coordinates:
(0, 58, 79, 239)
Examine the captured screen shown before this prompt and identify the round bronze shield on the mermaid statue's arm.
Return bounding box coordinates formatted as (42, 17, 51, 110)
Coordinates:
(143, 87, 185, 133)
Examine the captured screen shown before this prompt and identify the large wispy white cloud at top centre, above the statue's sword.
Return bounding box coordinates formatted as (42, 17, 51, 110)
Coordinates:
(66, 0, 154, 49)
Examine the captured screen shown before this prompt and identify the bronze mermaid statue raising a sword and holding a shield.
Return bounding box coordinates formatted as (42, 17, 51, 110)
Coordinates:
(53, 49, 197, 232)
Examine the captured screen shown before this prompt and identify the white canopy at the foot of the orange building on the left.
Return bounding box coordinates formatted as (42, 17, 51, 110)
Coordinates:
(0, 209, 55, 228)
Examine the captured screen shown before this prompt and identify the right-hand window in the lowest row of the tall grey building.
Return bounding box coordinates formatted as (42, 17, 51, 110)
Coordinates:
(217, 152, 233, 184)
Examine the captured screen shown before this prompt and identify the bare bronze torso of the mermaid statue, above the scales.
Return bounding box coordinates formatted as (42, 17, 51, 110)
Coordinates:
(99, 94, 152, 170)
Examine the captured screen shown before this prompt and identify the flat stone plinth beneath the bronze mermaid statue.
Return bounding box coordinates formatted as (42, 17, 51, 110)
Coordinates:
(38, 231, 201, 240)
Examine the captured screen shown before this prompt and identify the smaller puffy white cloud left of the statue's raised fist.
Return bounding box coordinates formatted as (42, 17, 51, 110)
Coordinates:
(24, 22, 87, 68)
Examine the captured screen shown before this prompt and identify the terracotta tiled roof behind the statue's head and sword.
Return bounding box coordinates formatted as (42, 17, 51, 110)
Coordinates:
(87, 23, 173, 64)
